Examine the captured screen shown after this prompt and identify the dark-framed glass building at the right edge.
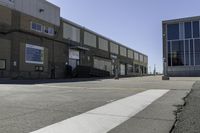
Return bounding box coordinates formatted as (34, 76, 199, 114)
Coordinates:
(163, 17, 200, 76)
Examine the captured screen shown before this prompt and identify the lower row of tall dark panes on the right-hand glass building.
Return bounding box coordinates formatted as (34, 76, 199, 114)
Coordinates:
(168, 39, 200, 66)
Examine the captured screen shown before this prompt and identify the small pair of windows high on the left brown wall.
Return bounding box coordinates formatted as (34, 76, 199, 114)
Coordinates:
(31, 22, 54, 36)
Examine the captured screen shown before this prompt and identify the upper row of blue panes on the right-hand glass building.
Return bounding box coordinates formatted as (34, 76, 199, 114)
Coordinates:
(167, 21, 200, 40)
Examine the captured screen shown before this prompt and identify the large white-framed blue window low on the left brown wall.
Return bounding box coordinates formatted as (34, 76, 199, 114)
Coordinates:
(25, 44, 44, 64)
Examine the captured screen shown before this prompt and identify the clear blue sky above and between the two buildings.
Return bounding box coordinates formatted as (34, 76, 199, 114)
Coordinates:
(48, 0, 200, 72)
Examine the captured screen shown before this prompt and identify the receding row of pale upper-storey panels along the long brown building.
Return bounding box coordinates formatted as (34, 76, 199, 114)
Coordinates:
(62, 23, 147, 63)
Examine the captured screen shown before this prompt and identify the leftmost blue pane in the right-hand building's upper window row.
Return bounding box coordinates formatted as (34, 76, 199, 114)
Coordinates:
(167, 24, 179, 40)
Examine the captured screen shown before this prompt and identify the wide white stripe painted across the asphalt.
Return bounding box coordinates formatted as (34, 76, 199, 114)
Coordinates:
(32, 90, 169, 133)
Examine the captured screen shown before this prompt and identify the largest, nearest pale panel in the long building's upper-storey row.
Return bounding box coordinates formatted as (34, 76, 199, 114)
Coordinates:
(63, 23, 80, 43)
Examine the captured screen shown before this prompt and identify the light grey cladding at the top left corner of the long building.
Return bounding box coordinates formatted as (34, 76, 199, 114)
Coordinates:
(0, 0, 60, 26)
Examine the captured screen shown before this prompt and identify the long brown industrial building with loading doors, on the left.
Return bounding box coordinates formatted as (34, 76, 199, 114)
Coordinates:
(0, 0, 148, 79)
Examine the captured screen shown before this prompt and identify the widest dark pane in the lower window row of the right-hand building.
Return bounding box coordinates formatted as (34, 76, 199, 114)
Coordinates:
(172, 41, 184, 66)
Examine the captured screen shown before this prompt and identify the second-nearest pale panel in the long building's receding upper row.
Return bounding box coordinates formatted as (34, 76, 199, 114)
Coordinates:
(84, 31, 97, 48)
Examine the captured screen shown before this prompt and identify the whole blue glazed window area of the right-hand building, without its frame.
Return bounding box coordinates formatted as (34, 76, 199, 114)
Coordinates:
(167, 21, 200, 66)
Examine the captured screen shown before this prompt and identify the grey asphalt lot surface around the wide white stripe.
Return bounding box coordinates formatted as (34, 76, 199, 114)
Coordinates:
(0, 76, 200, 133)
